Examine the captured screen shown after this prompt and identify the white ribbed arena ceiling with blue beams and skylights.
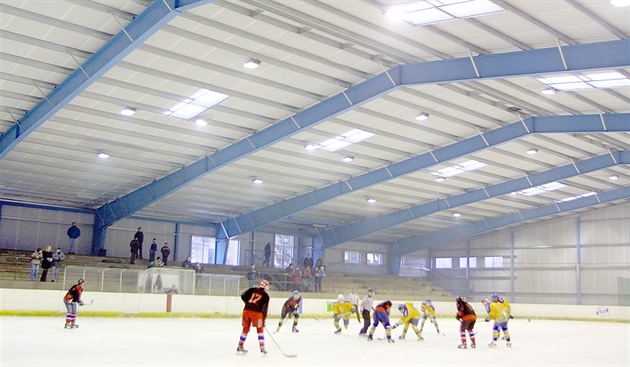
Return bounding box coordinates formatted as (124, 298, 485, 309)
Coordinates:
(0, 0, 630, 253)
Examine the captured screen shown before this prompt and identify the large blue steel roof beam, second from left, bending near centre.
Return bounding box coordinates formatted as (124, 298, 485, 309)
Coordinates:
(95, 39, 630, 231)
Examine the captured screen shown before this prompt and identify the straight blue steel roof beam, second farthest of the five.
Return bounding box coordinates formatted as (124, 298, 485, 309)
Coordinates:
(319, 151, 630, 248)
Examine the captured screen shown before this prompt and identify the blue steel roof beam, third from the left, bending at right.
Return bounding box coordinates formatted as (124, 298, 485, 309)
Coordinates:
(222, 114, 630, 239)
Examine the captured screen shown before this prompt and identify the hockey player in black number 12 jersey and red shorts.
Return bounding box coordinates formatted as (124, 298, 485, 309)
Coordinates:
(236, 279, 269, 353)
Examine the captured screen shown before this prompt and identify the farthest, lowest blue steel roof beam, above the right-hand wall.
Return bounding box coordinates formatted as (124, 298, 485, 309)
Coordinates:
(389, 186, 630, 257)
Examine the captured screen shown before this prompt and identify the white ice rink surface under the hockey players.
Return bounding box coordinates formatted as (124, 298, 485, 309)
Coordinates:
(0, 314, 630, 367)
